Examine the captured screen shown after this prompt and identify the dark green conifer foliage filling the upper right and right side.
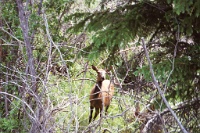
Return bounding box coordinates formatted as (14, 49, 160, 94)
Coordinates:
(69, 0, 200, 99)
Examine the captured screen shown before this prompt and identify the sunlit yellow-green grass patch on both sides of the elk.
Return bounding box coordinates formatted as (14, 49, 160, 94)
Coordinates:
(47, 74, 144, 133)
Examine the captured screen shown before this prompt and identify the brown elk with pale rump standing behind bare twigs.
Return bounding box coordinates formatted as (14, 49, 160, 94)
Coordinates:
(89, 65, 114, 123)
